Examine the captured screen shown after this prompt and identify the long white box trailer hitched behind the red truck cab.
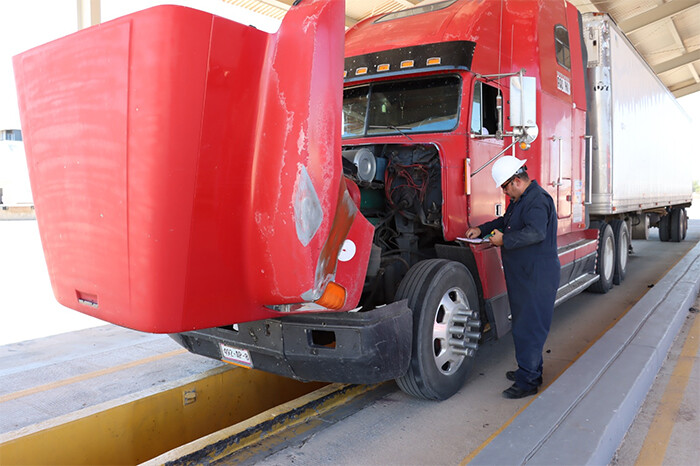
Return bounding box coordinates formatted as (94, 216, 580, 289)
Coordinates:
(582, 13, 693, 292)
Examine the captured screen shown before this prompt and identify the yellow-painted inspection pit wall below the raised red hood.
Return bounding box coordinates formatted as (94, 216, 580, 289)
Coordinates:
(0, 366, 324, 465)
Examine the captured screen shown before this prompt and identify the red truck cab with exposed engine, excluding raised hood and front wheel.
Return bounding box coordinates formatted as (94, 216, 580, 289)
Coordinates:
(343, 0, 596, 336)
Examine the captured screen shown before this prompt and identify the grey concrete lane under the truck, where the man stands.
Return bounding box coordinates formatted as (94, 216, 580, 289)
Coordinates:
(247, 220, 700, 465)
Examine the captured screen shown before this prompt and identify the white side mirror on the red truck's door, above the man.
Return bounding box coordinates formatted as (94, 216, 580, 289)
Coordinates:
(510, 75, 539, 144)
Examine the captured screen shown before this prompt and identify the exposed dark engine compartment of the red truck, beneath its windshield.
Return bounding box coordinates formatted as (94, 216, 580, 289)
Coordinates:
(343, 144, 444, 310)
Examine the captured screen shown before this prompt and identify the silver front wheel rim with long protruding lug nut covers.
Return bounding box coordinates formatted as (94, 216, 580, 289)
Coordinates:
(433, 288, 479, 375)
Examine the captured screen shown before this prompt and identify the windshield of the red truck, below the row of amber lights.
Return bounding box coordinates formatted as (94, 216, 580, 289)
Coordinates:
(343, 76, 461, 138)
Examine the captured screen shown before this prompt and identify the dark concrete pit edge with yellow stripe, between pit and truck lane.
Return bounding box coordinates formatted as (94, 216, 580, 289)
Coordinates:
(144, 384, 382, 466)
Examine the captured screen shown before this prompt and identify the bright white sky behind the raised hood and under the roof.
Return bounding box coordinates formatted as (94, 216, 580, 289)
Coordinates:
(0, 0, 700, 181)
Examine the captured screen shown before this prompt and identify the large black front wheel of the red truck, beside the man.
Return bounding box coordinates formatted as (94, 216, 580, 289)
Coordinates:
(396, 259, 481, 400)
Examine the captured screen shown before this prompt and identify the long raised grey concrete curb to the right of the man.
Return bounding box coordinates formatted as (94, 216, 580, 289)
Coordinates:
(470, 245, 700, 465)
